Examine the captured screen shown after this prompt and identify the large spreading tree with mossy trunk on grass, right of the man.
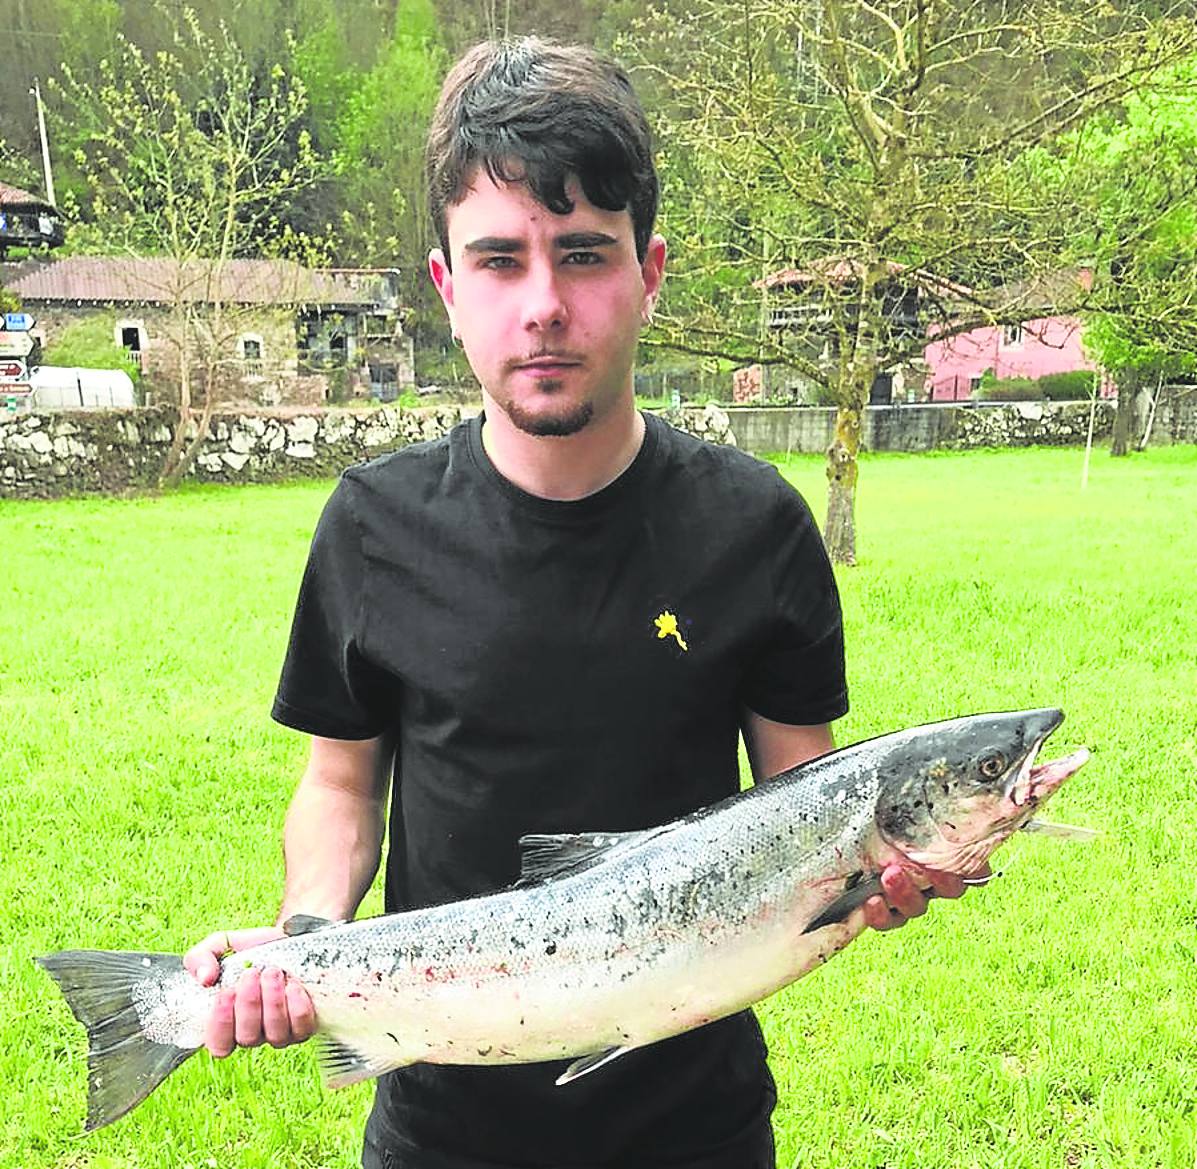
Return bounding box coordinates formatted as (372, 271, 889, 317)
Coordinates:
(619, 0, 1197, 564)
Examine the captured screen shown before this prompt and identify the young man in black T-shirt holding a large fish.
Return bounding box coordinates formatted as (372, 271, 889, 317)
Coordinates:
(187, 39, 960, 1169)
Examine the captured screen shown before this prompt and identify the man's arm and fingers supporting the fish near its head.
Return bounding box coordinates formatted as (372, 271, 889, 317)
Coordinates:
(741, 710, 965, 930)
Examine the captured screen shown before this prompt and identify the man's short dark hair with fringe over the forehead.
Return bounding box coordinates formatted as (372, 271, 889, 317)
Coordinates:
(426, 37, 658, 260)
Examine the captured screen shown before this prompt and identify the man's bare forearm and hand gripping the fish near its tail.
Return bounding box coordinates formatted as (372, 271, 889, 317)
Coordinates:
(183, 737, 394, 1057)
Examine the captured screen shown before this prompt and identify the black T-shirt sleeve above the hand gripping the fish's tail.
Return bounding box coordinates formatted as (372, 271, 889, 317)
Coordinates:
(271, 479, 395, 739)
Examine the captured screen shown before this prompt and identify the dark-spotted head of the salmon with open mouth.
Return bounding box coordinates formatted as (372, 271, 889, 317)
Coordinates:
(876, 708, 1088, 875)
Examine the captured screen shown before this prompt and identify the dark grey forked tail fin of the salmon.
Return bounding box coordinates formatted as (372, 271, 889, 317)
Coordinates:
(35, 950, 196, 1132)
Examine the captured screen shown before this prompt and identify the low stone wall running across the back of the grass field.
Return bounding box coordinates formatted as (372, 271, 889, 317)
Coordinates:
(0, 389, 1197, 498)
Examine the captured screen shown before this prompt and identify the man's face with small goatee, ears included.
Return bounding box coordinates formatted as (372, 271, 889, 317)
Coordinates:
(429, 171, 664, 434)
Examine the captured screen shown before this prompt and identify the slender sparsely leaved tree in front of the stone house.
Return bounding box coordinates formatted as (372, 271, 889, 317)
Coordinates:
(61, 7, 320, 483)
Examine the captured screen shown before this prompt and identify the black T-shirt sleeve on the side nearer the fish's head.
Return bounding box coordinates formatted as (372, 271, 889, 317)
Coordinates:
(743, 475, 847, 725)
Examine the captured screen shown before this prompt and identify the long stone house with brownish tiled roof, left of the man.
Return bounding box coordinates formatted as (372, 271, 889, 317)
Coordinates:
(7, 256, 415, 406)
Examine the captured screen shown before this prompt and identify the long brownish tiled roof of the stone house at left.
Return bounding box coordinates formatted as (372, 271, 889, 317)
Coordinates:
(10, 256, 376, 306)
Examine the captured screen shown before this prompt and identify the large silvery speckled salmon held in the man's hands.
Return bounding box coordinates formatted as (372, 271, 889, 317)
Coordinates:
(37, 710, 1088, 1130)
